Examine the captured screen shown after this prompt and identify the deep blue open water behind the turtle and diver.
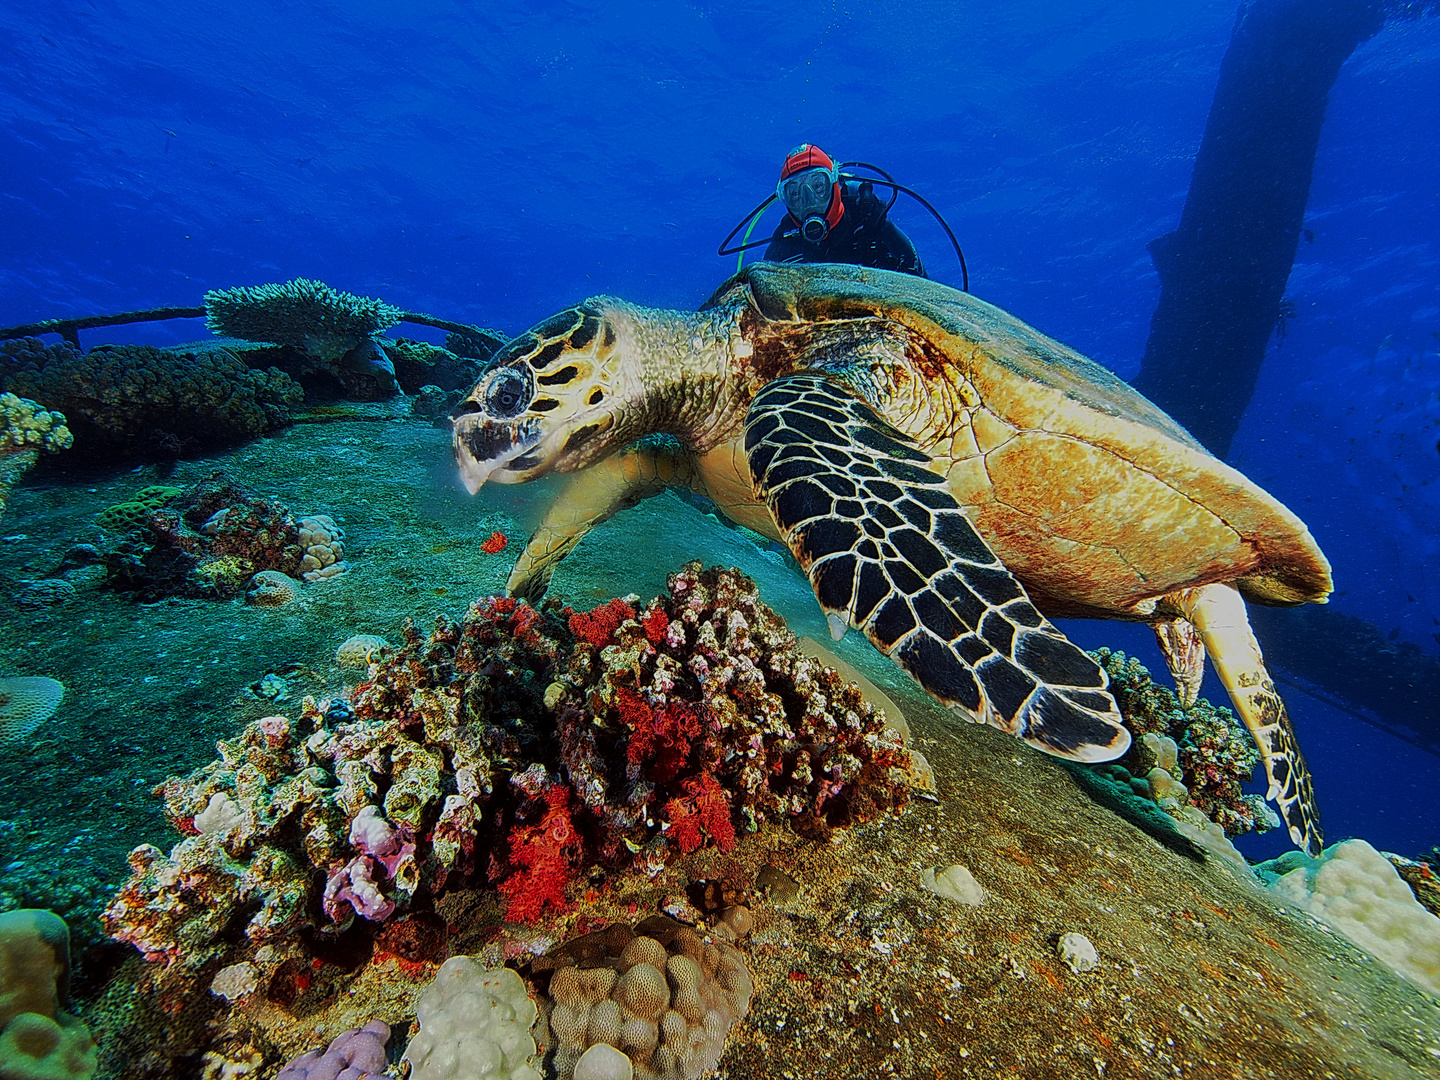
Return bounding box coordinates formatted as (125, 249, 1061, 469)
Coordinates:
(0, 0, 1440, 854)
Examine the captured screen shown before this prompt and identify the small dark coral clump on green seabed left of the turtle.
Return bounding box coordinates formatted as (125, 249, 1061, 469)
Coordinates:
(102, 471, 344, 606)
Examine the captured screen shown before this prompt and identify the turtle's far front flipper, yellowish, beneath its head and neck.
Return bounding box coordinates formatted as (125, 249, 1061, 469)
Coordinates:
(505, 445, 694, 603)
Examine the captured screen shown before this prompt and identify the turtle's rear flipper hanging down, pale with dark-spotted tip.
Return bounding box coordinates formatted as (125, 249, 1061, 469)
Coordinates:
(1165, 582, 1325, 855)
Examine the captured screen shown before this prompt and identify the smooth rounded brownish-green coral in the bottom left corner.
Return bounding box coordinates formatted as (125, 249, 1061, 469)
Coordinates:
(0, 909, 95, 1080)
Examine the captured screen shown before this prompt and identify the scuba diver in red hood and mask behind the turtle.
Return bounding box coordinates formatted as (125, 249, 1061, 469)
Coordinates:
(719, 143, 969, 291)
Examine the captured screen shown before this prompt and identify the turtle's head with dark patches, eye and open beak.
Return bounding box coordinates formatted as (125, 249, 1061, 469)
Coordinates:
(451, 301, 616, 494)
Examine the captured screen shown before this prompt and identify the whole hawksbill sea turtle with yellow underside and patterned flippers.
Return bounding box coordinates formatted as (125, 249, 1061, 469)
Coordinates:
(454, 262, 1331, 852)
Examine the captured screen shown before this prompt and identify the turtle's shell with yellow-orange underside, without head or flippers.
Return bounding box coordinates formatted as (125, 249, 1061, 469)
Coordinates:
(711, 264, 1331, 618)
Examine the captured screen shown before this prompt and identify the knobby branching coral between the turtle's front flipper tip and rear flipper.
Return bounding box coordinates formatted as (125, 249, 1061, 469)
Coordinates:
(1092, 648, 1270, 837)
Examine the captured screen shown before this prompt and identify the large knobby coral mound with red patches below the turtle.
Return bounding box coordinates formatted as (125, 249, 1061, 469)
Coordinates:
(105, 563, 917, 1002)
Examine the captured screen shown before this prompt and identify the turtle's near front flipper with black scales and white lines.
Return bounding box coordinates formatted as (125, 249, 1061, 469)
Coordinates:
(744, 373, 1130, 762)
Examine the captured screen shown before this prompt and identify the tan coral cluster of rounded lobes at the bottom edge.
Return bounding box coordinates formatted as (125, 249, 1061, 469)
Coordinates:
(531, 916, 755, 1080)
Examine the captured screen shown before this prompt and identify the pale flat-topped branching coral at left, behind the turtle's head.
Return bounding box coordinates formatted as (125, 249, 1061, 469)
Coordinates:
(204, 278, 405, 363)
